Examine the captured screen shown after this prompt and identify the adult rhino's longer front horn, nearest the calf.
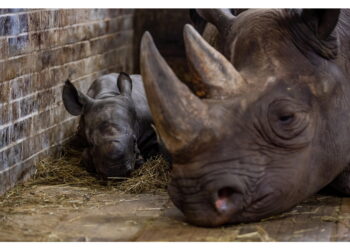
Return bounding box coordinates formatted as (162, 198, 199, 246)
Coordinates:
(140, 32, 208, 155)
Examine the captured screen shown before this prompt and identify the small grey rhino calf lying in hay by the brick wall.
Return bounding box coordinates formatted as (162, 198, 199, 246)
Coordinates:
(62, 73, 158, 177)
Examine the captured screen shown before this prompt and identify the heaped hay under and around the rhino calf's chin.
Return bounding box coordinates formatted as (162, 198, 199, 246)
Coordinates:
(26, 147, 170, 194)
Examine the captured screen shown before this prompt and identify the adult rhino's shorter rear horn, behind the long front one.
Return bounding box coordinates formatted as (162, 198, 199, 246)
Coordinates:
(184, 24, 244, 99)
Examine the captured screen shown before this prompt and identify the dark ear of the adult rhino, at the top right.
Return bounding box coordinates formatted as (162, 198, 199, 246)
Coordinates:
(301, 9, 340, 39)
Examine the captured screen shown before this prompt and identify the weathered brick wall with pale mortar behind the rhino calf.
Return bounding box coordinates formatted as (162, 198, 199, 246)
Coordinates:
(0, 9, 134, 193)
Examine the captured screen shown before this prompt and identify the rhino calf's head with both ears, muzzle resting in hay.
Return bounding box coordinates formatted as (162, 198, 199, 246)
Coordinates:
(63, 73, 139, 177)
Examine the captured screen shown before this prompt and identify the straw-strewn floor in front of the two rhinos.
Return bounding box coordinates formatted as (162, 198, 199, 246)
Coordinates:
(0, 148, 350, 241)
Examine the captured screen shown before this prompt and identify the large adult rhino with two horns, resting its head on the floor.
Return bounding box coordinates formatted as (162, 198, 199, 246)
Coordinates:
(141, 9, 350, 226)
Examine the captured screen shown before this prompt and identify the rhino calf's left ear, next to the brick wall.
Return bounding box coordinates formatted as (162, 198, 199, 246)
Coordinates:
(62, 80, 93, 115)
